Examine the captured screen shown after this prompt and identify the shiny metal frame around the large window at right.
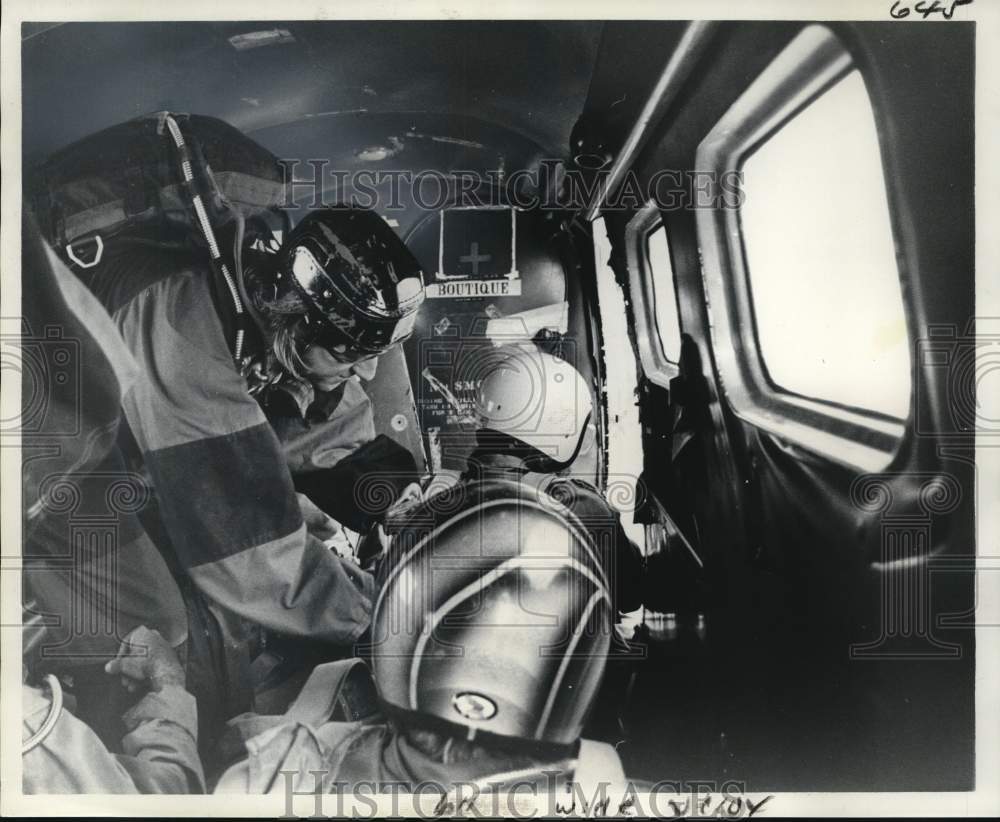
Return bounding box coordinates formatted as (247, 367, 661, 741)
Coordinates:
(695, 24, 913, 471)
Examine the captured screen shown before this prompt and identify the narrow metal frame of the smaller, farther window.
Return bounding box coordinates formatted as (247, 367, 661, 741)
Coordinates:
(625, 201, 684, 388)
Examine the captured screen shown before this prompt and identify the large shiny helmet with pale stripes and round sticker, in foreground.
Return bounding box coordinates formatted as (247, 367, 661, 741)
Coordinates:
(371, 479, 613, 748)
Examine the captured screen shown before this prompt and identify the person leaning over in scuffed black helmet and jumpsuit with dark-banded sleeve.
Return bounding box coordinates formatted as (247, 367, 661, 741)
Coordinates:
(62, 204, 423, 745)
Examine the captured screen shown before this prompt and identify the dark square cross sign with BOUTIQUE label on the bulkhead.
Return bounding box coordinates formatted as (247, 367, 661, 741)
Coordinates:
(427, 207, 521, 299)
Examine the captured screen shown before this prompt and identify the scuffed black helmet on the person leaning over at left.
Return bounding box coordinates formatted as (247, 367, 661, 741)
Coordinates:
(276, 207, 424, 358)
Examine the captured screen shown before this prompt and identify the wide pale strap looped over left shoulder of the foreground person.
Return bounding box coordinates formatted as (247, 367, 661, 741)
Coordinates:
(285, 659, 378, 727)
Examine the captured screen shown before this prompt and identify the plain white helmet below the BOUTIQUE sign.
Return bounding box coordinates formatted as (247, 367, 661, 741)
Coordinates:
(476, 343, 592, 465)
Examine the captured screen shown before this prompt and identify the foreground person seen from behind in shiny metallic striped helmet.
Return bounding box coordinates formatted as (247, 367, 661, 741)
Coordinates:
(215, 478, 622, 797)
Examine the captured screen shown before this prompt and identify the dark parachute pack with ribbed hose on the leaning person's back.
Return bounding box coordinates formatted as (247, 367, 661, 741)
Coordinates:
(27, 111, 287, 360)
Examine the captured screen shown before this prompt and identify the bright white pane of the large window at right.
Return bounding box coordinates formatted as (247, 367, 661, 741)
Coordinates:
(740, 70, 911, 419)
